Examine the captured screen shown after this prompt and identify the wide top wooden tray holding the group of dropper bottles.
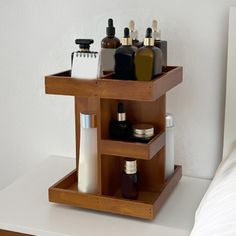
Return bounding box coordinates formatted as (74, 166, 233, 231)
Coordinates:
(45, 66, 183, 101)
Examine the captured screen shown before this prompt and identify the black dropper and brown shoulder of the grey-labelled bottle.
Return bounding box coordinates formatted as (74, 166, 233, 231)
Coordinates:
(101, 18, 120, 48)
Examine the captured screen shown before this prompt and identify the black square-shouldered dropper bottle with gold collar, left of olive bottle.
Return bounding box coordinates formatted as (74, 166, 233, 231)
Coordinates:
(115, 28, 137, 80)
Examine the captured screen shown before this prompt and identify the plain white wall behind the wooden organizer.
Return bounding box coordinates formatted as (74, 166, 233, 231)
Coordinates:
(0, 0, 236, 188)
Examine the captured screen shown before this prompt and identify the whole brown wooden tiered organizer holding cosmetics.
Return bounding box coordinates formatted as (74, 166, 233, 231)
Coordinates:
(45, 67, 182, 219)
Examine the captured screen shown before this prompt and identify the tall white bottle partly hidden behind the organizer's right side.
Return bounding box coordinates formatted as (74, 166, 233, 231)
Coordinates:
(165, 113, 175, 179)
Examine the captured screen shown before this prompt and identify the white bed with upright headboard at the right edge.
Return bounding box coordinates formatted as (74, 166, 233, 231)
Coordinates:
(191, 7, 236, 236)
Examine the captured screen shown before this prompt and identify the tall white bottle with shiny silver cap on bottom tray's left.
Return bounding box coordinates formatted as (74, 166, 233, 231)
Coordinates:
(78, 113, 98, 193)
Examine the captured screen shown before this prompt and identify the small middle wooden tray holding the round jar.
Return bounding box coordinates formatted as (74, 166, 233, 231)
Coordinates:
(101, 132, 165, 160)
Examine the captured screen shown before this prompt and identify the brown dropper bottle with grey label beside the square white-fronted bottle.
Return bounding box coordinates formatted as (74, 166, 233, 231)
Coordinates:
(100, 19, 121, 77)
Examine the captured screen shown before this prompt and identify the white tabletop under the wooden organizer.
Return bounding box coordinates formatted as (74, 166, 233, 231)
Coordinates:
(0, 157, 210, 236)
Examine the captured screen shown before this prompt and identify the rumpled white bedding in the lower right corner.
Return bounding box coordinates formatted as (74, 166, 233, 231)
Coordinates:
(190, 148, 236, 236)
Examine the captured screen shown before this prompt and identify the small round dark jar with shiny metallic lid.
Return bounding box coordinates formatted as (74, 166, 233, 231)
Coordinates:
(132, 124, 154, 143)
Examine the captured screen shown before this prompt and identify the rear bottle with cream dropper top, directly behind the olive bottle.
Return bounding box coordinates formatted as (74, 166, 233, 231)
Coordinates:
(152, 20, 167, 66)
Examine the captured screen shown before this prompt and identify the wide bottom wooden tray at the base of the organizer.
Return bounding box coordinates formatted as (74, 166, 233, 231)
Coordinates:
(49, 166, 182, 220)
